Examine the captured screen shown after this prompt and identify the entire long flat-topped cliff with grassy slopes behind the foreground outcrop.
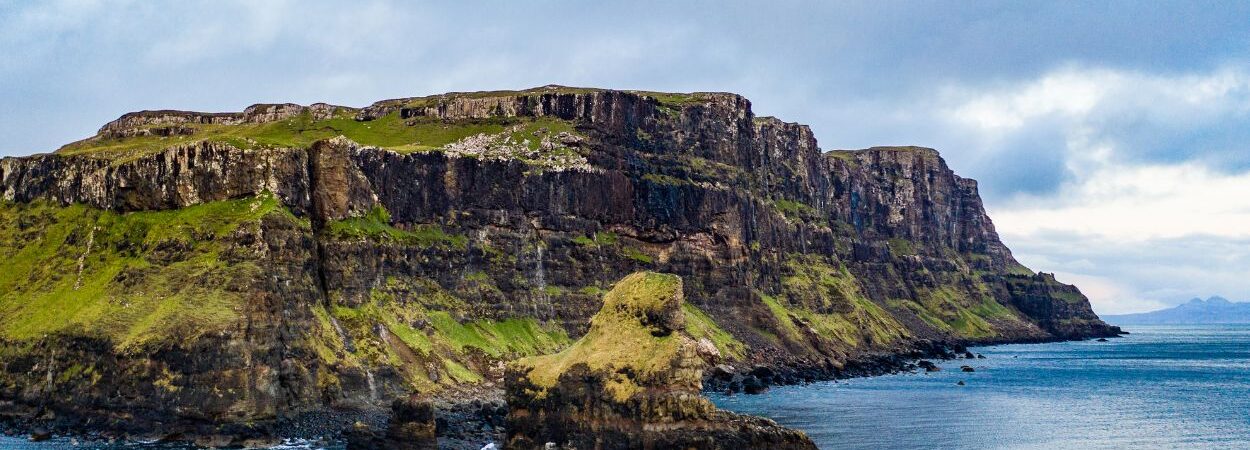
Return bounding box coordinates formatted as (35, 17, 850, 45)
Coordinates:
(0, 86, 1115, 437)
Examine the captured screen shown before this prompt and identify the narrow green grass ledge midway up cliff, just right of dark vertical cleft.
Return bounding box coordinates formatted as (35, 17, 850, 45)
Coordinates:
(325, 205, 469, 250)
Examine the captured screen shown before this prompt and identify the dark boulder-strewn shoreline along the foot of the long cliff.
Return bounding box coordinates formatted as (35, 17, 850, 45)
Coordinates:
(0, 330, 1126, 450)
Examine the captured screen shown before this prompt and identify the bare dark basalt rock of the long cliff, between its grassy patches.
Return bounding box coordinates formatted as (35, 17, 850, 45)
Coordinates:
(0, 88, 1123, 439)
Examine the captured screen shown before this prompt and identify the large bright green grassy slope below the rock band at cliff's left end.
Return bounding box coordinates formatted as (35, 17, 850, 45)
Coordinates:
(0, 195, 295, 353)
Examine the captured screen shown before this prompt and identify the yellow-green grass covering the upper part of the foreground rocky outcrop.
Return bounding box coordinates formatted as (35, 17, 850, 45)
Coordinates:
(519, 273, 690, 403)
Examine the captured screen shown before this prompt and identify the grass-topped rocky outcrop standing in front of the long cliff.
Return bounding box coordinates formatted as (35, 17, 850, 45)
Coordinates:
(506, 273, 816, 449)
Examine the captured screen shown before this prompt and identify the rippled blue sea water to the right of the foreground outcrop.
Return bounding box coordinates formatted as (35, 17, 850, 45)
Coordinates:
(713, 325, 1250, 449)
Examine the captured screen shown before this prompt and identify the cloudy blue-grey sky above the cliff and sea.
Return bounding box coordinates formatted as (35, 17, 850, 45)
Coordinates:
(0, 0, 1250, 314)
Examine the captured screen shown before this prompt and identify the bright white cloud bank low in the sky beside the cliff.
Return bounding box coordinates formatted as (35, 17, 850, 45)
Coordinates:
(935, 66, 1250, 314)
